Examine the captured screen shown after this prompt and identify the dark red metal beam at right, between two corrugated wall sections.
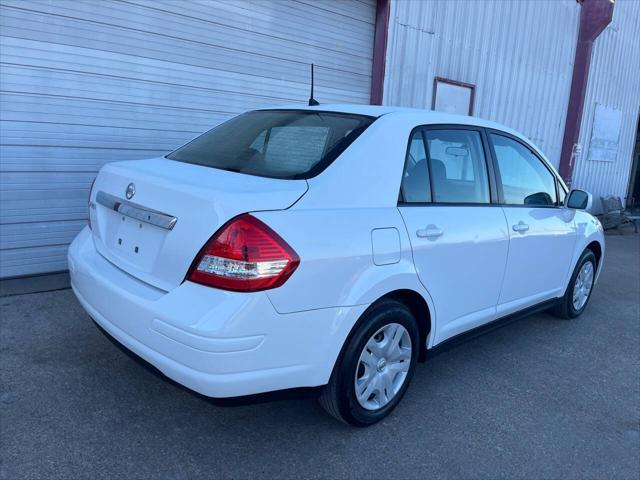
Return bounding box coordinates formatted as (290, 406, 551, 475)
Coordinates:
(558, 0, 614, 185)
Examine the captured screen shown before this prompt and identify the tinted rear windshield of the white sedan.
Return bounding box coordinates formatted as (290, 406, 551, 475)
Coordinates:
(167, 110, 375, 179)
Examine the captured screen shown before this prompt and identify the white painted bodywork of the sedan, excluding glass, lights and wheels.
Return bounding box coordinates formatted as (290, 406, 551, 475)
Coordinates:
(69, 105, 605, 397)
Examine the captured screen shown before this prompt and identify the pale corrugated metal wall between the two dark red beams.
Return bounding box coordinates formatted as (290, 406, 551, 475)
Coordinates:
(384, 0, 580, 166)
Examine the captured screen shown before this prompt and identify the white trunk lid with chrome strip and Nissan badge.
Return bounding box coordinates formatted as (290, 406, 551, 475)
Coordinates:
(90, 158, 308, 291)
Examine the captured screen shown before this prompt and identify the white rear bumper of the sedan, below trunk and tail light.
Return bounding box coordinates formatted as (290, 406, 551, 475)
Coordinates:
(69, 228, 366, 397)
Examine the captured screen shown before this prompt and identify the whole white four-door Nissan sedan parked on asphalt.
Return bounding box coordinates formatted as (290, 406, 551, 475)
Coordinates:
(69, 105, 605, 426)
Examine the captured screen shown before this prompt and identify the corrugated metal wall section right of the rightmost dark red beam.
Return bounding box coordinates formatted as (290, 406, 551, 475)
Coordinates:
(572, 0, 640, 213)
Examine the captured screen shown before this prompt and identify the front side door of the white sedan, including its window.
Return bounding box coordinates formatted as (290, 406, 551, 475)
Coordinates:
(488, 131, 576, 315)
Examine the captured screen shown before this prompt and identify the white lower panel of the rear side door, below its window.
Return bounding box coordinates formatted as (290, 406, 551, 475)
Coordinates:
(399, 205, 509, 343)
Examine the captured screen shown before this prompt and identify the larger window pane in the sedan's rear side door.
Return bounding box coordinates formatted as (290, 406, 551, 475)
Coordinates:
(424, 129, 489, 203)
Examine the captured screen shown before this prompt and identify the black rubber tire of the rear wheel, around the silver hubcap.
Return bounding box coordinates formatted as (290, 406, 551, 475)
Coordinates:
(319, 299, 420, 427)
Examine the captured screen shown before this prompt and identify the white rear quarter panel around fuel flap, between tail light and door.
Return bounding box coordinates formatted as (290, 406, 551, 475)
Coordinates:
(255, 208, 436, 313)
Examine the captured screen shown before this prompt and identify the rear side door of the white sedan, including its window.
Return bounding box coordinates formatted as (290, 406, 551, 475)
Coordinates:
(399, 126, 509, 343)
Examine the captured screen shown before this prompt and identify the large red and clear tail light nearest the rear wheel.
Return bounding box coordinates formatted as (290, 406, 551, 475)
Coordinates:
(187, 214, 300, 292)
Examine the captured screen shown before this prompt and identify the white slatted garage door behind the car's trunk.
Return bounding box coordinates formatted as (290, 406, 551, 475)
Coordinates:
(0, 0, 375, 277)
